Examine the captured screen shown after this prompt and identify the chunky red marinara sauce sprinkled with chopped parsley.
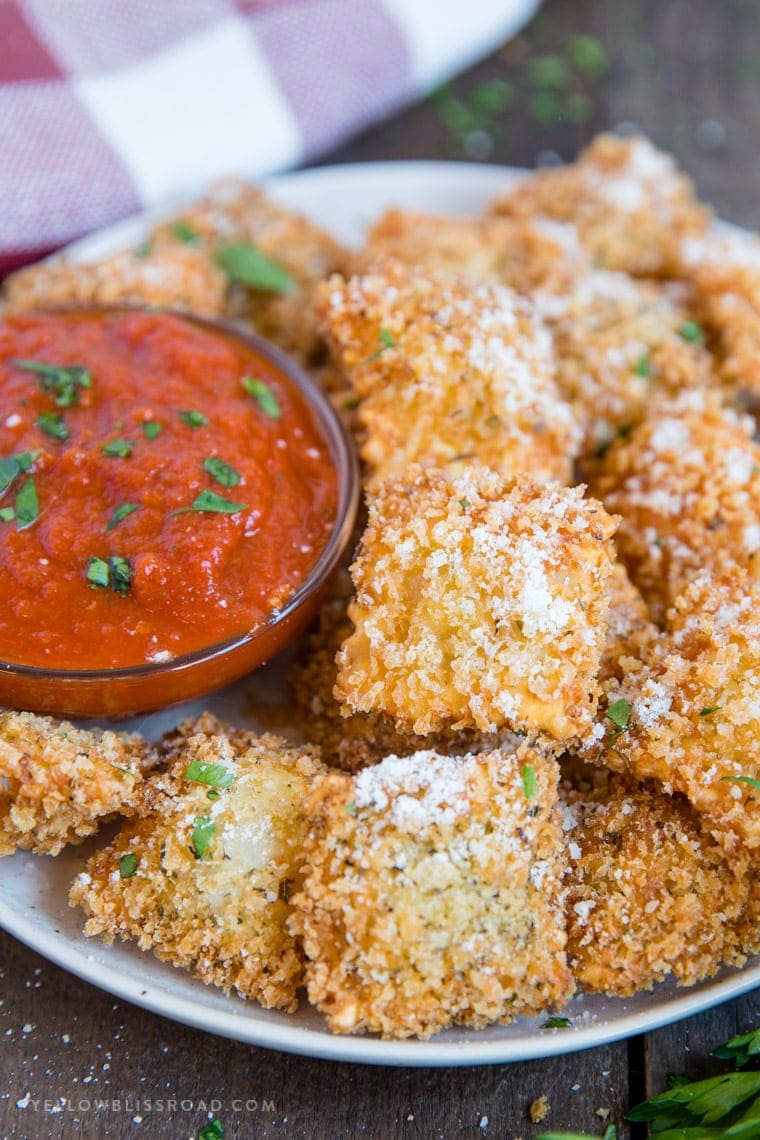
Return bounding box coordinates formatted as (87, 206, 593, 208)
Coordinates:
(0, 311, 337, 669)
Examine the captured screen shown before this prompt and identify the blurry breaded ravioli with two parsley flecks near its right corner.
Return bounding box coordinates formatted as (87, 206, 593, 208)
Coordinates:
(536, 270, 717, 455)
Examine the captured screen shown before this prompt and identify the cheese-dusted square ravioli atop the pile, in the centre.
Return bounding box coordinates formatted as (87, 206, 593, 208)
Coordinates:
(335, 467, 614, 741)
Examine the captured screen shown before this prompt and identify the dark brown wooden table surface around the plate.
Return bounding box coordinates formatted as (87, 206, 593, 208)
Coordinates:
(0, 0, 760, 1140)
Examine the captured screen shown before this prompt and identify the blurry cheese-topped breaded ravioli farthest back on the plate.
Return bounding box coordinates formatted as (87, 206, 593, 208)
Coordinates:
(491, 135, 710, 277)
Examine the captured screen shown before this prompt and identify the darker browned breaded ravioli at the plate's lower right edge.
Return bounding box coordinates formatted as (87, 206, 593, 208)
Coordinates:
(566, 782, 750, 998)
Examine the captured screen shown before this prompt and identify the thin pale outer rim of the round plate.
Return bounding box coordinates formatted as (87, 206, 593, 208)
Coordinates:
(0, 160, 760, 1068)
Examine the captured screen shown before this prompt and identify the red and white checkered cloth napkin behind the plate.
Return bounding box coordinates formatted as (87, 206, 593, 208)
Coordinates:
(0, 0, 539, 271)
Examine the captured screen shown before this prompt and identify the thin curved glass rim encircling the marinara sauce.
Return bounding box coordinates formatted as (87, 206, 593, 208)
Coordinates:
(0, 304, 361, 685)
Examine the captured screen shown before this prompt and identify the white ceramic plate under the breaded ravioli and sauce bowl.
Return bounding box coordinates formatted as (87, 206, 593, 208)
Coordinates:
(0, 162, 760, 1066)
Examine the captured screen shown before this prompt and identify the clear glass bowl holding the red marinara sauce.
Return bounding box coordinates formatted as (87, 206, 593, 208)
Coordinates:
(0, 306, 359, 718)
